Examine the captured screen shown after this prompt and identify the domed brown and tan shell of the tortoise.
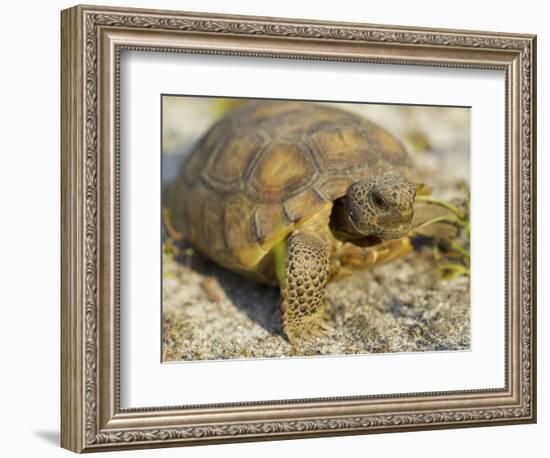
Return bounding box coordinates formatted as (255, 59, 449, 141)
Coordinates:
(167, 101, 410, 272)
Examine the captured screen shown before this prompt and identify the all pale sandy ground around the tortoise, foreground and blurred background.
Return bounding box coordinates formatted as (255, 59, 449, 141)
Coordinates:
(162, 99, 470, 361)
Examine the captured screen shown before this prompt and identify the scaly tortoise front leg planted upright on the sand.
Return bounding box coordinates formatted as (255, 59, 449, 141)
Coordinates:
(279, 232, 331, 345)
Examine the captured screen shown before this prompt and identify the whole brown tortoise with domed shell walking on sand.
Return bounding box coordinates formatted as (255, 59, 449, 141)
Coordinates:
(166, 101, 421, 344)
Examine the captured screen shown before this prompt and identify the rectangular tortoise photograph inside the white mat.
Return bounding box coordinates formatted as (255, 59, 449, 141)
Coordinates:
(159, 95, 470, 362)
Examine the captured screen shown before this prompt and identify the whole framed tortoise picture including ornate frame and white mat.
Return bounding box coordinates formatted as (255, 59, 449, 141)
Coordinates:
(61, 6, 536, 452)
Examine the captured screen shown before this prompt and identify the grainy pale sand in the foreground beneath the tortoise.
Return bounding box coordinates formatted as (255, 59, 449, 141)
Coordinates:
(163, 243, 470, 361)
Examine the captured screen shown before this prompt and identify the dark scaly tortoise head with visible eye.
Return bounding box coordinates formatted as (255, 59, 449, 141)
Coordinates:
(343, 174, 416, 240)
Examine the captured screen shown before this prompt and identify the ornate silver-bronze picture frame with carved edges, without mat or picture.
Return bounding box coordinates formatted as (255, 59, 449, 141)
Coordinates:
(61, 6, 536, 452)
